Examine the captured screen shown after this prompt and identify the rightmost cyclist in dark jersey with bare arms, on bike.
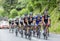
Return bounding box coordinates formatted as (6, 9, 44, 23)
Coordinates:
(42, 11, 50, 39)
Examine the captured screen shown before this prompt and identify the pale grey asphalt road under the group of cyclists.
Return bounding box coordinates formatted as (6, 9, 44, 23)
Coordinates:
(0, 29, 60, 41)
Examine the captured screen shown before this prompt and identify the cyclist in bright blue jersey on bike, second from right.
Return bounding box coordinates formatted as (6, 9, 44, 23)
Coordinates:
(36, 14, 42, 38)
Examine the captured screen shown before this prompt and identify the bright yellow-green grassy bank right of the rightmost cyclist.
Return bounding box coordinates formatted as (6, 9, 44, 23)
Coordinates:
(50, 7, 60, 33)
